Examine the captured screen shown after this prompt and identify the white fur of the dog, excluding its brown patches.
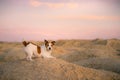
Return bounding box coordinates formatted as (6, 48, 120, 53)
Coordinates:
(24, 43, 55, 61)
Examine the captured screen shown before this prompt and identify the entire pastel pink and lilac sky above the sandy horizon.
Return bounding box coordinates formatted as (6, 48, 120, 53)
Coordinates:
(0, 0, 120, 41)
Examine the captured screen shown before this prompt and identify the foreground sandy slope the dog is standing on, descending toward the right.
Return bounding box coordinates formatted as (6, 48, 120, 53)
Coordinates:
(0, 58, 120, 80)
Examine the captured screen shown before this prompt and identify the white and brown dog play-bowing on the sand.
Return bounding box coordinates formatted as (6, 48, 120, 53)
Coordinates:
(22, 40, 56, 61)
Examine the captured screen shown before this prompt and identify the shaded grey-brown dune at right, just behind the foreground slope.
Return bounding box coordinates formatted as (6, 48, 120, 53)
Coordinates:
(73, 58, 120, 74)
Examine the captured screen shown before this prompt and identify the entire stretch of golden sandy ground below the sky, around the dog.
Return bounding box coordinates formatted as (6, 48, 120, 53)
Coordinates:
(0, 39, 120, 80)
